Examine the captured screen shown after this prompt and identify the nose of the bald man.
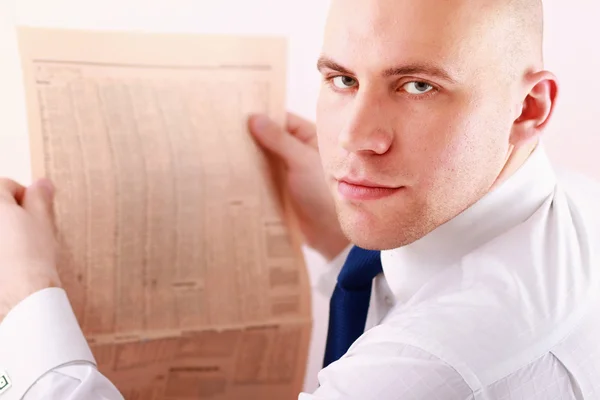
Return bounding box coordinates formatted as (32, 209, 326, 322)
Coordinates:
(338, 92, 394, 155)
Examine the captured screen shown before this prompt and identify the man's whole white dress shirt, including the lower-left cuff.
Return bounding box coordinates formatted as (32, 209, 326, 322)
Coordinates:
(0, 147, 600, 400)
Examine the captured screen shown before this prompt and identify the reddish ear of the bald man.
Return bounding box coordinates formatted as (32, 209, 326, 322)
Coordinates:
(510, 71, 558, 146)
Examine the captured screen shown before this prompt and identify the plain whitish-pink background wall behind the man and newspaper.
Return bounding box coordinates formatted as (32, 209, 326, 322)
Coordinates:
(0, 0, 600, 390)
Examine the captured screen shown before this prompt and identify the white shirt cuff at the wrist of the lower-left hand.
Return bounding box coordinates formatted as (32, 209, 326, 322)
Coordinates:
(0, 288, 96, 400)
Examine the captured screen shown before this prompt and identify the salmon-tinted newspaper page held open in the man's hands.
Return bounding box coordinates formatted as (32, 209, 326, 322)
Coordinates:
(18, 27, 311, 400)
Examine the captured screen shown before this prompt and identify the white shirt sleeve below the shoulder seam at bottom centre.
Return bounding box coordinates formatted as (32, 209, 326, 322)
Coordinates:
(299, 343, 473, 400)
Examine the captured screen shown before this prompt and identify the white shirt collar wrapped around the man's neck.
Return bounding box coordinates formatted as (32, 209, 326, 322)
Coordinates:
(381, 145, 556, 302)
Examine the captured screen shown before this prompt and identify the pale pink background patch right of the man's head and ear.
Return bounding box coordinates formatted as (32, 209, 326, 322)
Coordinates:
(545, 0, 600, 179)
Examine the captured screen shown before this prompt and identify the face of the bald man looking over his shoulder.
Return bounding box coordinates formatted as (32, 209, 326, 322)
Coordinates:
(317, 0, 518, 249)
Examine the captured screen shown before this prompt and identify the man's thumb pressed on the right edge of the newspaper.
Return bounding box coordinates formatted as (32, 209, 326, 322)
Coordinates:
(248, 115, 306, 166)
